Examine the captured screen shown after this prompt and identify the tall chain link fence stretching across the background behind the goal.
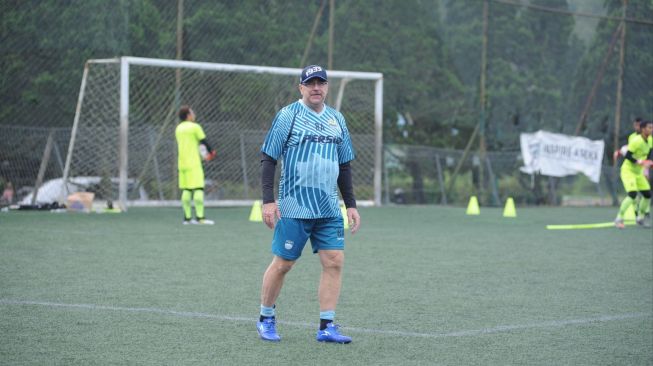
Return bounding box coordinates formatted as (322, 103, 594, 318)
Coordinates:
(0, 0, 653, 209)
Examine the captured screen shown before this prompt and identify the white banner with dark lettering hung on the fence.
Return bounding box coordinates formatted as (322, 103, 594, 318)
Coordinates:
(519, 131, 605, 183)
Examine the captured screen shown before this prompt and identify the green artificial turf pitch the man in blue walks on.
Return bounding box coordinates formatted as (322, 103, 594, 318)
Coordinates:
(0, 206, 653, 365)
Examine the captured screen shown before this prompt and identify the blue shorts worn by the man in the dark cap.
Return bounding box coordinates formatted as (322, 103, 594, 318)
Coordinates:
(272, 216, 345, 261)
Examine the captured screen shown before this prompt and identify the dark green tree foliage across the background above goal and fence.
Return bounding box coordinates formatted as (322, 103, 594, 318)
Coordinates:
(0, 0, 653, 149)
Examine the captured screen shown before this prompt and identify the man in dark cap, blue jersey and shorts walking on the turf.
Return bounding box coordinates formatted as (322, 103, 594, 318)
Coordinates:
(257, 65, 361, 343)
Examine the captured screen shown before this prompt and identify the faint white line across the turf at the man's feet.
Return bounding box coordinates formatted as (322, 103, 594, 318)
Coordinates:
(0, 299, 653, 338)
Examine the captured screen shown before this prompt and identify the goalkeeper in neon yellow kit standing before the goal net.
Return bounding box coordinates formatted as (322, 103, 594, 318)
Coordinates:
(175, 105, 215, 225)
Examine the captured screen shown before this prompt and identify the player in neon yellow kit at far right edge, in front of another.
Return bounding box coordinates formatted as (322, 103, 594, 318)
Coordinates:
(614, 121, 653, 229)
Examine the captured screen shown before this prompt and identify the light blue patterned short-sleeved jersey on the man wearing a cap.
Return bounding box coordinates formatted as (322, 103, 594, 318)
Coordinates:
(261, 99, 355, 219)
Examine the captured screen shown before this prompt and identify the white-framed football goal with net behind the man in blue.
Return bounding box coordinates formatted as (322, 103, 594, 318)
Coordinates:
(61, 57, 383, 209)
